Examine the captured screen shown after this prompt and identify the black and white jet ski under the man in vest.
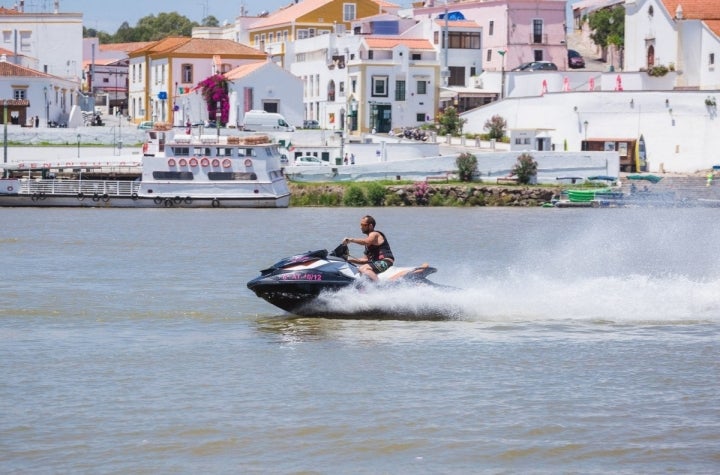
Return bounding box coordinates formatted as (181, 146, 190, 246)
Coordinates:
(247, 244, 437, 315)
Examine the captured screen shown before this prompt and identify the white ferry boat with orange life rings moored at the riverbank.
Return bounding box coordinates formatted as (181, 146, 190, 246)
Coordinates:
(0, 130, 290, 208)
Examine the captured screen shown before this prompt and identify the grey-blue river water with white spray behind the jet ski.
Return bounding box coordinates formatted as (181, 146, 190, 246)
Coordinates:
(0, 208, 720, 474)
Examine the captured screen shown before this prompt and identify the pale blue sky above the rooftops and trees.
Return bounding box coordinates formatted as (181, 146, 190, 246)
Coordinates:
(50, 0, 411, 34)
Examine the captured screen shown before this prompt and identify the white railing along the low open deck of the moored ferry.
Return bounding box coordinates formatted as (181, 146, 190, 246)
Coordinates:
(20, 180, 140, 196)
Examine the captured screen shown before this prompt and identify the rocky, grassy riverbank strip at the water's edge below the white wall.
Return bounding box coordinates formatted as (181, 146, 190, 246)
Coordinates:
(290, 181, 562, 207)
